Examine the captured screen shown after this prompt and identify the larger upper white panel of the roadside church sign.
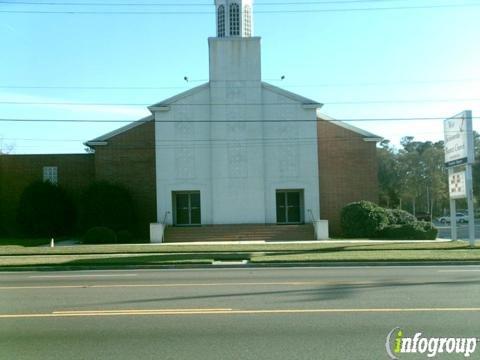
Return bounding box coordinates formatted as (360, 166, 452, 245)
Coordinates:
(443, 112, 473, 167)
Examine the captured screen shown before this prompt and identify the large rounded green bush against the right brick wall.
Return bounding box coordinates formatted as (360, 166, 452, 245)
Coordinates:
(340, 201, 388, 238)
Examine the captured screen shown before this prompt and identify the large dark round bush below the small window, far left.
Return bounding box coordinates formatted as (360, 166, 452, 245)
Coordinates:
(17, 181, 75, 237)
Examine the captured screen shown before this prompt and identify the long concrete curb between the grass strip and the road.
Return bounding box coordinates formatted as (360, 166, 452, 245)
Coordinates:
(0, 261, 480, 272)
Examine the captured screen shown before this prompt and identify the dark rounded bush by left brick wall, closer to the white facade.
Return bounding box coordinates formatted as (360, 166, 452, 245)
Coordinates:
(81, 182, 135, 231)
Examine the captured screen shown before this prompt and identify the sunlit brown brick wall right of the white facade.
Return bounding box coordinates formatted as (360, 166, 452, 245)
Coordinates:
(317, 120, 378, 235)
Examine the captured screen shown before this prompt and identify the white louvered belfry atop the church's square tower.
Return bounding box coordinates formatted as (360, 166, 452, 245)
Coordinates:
(215, 0, 253, 38)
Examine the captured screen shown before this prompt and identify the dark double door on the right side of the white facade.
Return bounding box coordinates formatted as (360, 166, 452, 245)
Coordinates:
(276, 190, 303, 224)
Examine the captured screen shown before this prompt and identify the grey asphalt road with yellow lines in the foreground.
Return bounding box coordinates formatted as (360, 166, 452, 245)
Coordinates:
(0, 267, 480, 360)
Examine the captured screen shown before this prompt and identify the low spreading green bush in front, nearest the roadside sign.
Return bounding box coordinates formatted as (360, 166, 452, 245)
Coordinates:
(377, 221, 438, 240)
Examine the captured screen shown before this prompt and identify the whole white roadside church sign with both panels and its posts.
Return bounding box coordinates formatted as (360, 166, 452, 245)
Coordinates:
(444, 110, 475, 246)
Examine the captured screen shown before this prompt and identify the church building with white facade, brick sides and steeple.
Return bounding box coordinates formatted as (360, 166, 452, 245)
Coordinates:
(0, 0, 381, 242)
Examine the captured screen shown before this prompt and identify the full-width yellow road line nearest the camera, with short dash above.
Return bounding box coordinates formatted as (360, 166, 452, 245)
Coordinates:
(0, 308, 480, 319)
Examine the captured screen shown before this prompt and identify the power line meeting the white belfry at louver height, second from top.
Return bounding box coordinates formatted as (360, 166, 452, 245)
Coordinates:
(0, 3, 480, 15)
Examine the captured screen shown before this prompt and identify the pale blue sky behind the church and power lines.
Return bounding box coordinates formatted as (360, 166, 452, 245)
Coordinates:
(0, 0, 480, 154)
